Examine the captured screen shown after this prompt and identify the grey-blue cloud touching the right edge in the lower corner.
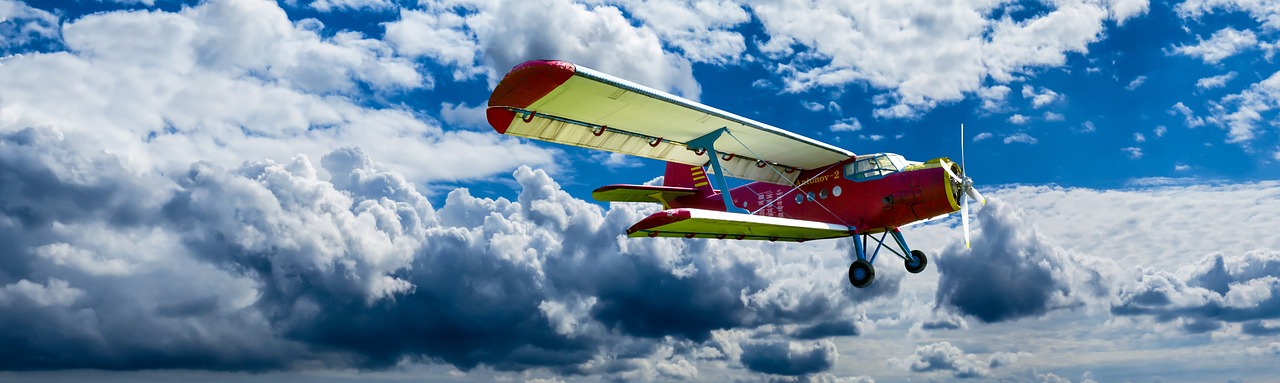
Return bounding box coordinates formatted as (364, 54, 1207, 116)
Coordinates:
(1111, 249, 1280, 336)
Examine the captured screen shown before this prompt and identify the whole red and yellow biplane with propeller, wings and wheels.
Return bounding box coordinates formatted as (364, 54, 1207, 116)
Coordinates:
(486, 60, 986, 288)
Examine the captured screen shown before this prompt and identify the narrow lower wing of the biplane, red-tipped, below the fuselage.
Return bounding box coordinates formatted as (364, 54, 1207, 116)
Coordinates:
(627, 209, 852, 242)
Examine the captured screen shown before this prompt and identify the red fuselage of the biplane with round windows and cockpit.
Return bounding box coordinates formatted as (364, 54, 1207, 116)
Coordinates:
(671, 154, 961, 233)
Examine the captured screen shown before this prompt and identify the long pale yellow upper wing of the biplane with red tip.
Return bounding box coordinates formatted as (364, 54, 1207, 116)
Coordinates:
(488, 60, 854, 184)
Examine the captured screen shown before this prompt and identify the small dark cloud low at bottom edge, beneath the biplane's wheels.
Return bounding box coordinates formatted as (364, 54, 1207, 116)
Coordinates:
(741, 339, 840, 375)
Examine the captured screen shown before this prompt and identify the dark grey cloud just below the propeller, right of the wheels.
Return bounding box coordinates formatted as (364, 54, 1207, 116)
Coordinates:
(936, 199, 1107, 323)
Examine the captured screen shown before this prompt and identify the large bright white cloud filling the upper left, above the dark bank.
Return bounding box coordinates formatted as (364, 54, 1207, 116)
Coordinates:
(0, 0, 553, 181)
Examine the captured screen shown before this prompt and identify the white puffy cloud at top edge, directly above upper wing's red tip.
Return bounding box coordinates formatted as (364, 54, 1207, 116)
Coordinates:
(387, 0, 701, 100)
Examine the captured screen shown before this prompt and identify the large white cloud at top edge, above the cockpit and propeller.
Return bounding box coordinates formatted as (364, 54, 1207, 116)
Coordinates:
(751, 0, 1147, 117)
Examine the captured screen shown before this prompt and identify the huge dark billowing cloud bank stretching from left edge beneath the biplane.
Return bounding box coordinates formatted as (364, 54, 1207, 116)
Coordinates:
(0, 128, 870, 379)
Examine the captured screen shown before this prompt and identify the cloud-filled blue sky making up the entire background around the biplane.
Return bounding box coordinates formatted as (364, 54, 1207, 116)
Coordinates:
(0, 0, 1280, 382)
